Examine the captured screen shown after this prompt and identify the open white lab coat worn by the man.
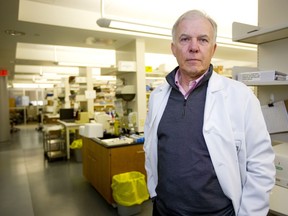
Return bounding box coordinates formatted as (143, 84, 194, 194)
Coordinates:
(144, 72, 275, 216)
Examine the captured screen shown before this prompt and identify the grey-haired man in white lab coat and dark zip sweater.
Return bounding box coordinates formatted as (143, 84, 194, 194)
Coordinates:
(144, 10, 275, 216)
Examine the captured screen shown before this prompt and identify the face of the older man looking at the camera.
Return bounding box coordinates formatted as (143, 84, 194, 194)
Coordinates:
(171, 17, 216, 80)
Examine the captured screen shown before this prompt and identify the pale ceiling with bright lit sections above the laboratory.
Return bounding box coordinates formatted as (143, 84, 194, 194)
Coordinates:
(0, 0, 258, 88)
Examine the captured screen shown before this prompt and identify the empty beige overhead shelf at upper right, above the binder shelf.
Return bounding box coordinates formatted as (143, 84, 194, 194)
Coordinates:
(232, 22, 288, 44)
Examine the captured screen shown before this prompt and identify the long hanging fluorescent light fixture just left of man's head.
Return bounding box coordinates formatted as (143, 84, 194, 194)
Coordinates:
(97, 18, 171, 36)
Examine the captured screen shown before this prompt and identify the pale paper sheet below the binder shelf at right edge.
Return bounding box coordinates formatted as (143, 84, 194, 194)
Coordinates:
(261, 101, 288, 134)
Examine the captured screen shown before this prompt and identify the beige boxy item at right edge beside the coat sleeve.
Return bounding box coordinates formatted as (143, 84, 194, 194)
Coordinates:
(273, 143, 288, 188)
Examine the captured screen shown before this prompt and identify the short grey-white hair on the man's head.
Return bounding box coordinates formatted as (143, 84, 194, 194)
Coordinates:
(172, 10, 217, 43)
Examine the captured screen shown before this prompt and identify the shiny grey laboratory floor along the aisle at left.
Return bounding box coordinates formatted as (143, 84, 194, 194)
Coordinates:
(0, 125, 152, 216)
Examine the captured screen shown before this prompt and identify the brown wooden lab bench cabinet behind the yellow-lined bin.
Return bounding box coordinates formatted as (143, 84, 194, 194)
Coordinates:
(82, 137, 146, 204)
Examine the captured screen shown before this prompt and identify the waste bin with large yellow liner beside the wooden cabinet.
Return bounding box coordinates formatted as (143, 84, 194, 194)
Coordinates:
(111, 171, 149, 216)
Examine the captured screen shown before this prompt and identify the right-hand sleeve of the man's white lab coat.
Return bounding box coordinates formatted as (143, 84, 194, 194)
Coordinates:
(237, 94, 275, 216)
